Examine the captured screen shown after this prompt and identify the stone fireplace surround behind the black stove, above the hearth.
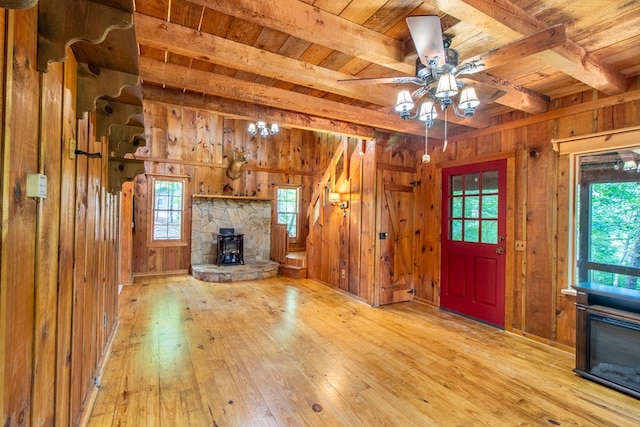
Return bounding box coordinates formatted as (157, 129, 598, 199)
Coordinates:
(191, 195, 271, 268)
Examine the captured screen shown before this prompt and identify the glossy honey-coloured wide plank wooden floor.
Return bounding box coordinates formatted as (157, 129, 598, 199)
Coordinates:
(89, 276, 640, 427)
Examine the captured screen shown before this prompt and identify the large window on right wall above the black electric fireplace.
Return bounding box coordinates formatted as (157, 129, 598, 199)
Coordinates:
(574, 148, 640, 290)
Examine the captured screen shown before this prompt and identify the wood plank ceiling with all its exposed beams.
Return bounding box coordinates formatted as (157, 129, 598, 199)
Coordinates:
(135, 0, 640, 138)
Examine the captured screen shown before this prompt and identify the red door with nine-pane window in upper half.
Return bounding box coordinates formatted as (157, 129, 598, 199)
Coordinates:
(440, 160, 507, 328)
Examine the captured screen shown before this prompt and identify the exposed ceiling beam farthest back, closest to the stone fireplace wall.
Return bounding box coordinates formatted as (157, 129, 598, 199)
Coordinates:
(142, 85, 375, 139)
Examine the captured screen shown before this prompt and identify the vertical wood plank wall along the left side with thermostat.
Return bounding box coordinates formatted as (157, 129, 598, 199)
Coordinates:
(0, 7, 119, 426)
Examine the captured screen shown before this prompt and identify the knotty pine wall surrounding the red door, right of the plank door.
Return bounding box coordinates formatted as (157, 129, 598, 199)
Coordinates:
(416, 85, 640, 349)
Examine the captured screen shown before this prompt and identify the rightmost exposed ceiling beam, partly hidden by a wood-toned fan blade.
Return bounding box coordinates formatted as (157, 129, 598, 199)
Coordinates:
(426, 0, 631, 95)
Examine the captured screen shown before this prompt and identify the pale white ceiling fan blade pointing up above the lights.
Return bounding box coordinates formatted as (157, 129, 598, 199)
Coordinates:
(407, 15, 445, 66)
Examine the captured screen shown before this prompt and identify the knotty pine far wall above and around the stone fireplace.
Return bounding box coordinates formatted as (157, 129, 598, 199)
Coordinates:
(132, 101, 348, 276)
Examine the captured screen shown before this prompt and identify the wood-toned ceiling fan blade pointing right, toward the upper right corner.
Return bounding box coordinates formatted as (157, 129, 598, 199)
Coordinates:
(459, 24, 567, 74)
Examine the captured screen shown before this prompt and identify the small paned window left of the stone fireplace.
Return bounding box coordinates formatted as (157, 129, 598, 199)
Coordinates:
(149, 177, 187, 246)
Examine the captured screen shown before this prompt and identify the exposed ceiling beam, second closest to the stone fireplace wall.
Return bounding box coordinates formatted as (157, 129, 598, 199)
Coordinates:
(140, 57, 444, 135)
